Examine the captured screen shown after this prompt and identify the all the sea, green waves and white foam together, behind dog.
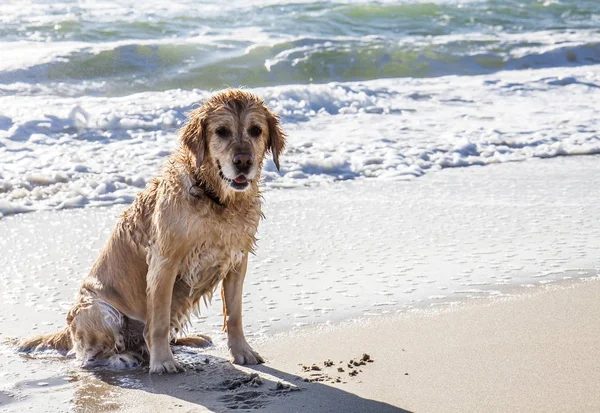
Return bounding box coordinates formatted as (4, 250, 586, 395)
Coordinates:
(0, 0, 600, 216)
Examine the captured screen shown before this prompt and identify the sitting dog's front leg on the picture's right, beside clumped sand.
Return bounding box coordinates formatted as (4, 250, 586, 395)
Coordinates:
(222, 252, 265, 364)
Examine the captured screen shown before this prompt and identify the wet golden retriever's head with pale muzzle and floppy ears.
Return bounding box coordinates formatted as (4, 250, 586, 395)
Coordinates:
(181, 90, 285, 191)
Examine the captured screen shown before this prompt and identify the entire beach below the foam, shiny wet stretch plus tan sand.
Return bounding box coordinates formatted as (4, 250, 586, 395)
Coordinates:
(0, 157, 600, 412)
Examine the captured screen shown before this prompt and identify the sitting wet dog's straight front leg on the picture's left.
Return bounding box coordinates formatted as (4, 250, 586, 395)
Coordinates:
(144, 252, 183, 374)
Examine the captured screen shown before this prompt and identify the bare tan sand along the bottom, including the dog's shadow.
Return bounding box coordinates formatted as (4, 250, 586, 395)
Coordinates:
(0, 279, 600, 412)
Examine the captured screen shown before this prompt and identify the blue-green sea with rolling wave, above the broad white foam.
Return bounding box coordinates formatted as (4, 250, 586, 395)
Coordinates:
(0, 0, 600, 96)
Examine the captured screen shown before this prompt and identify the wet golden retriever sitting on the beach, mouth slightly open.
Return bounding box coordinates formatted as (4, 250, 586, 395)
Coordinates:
(19, 90, 285, 373)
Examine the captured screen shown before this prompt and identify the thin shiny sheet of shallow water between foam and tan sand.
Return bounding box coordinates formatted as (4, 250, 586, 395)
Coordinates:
(0, 156, 600, 343)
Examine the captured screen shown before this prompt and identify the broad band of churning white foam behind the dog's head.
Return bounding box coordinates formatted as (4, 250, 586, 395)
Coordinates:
(0, 67, 600, 215)
